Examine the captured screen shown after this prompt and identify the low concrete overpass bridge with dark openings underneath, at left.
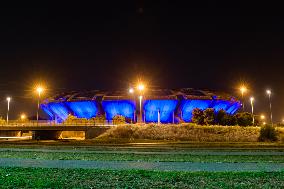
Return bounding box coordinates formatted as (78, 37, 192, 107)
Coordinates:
(0, 123, 115, 140)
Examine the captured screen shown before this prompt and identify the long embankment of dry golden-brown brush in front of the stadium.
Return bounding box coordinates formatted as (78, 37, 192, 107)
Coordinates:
(98, 123, 260, 142)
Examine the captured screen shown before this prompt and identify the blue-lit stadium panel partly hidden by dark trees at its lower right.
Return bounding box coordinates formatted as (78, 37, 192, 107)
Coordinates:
(181, 100, 212, 122)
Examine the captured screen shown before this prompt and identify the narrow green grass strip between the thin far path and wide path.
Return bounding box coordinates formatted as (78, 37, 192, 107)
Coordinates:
(0, 151, 284, 163)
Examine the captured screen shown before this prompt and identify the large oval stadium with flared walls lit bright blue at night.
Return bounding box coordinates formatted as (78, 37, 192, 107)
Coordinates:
(41, 88, 241, 123)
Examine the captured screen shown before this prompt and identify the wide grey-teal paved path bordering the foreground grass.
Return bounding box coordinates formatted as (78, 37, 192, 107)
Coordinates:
(0, 158, 284, 172)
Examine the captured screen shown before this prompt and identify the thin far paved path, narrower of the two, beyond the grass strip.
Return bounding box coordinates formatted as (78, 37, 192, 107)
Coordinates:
(0, 148, 284, 155)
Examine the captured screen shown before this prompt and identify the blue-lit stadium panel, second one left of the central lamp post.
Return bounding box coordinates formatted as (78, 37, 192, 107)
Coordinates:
(66, 101, 98, 119)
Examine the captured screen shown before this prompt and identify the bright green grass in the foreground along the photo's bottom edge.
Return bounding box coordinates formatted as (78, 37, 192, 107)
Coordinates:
(0, 168, 284, 188)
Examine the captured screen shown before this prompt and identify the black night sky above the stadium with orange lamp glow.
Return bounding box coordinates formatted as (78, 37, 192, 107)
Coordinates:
(0, 0, 284, 120)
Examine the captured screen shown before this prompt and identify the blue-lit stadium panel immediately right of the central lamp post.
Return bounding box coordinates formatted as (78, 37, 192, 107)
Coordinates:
(144, 100, 178, 123)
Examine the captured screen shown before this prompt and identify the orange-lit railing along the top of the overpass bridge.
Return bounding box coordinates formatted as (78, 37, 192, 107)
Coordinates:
(0, 120, 114, 126)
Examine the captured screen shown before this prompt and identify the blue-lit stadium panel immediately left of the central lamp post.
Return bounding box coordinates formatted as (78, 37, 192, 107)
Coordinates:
(102, 100, 135, 120)
